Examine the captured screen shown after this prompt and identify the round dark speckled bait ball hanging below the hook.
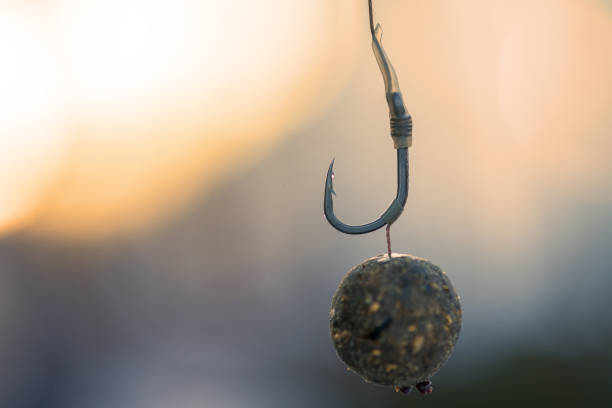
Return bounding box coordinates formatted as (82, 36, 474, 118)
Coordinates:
(329, 254, 461, 390)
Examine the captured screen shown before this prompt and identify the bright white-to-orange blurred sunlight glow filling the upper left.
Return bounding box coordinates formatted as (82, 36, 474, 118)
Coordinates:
(0, 0, 355, 236)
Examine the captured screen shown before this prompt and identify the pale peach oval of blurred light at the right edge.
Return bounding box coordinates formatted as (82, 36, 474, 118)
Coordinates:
(498, 1, 612, 189)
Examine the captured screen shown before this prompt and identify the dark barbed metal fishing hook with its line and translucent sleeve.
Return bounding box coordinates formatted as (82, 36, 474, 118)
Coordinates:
(323, 0, 412, 237)
